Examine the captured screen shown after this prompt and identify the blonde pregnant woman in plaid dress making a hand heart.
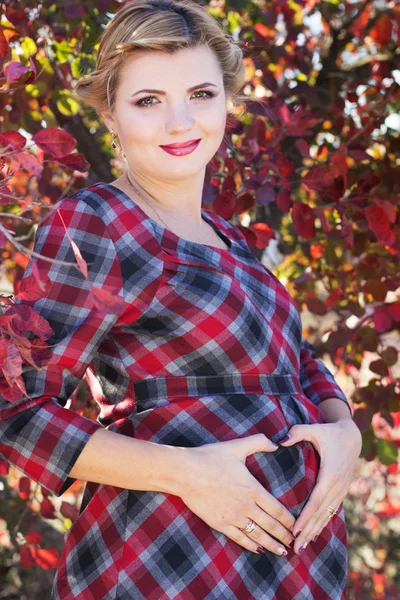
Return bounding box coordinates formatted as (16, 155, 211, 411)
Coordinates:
(0, 0, 361, 600)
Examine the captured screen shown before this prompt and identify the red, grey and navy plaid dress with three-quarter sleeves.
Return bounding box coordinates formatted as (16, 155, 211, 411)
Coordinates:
(0, 183, 349, 600)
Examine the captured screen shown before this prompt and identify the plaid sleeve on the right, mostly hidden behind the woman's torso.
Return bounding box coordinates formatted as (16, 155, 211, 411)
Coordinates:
(300, 338, 352, 413)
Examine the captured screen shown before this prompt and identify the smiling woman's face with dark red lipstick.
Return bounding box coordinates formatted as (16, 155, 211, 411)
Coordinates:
(105, 46, 227, 180)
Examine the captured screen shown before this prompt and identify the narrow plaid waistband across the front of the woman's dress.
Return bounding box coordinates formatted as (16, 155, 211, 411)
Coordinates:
(133, 373, 303, 401)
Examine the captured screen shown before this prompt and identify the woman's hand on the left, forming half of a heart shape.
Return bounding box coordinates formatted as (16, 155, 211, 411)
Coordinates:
(176, 433, 296, 555)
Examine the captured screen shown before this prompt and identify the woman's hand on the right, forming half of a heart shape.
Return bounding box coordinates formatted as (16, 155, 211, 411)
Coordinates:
(279, 418, 362, 554)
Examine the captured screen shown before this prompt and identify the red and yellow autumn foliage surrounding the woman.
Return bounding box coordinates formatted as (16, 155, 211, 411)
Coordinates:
(0, 0, 400, 599)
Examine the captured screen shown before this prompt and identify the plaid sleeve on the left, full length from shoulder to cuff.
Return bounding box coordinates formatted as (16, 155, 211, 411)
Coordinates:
(0, 198, 123, 496)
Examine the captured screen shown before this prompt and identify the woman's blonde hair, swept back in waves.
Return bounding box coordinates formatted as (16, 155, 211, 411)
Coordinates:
(74, 0, 264, 115)
